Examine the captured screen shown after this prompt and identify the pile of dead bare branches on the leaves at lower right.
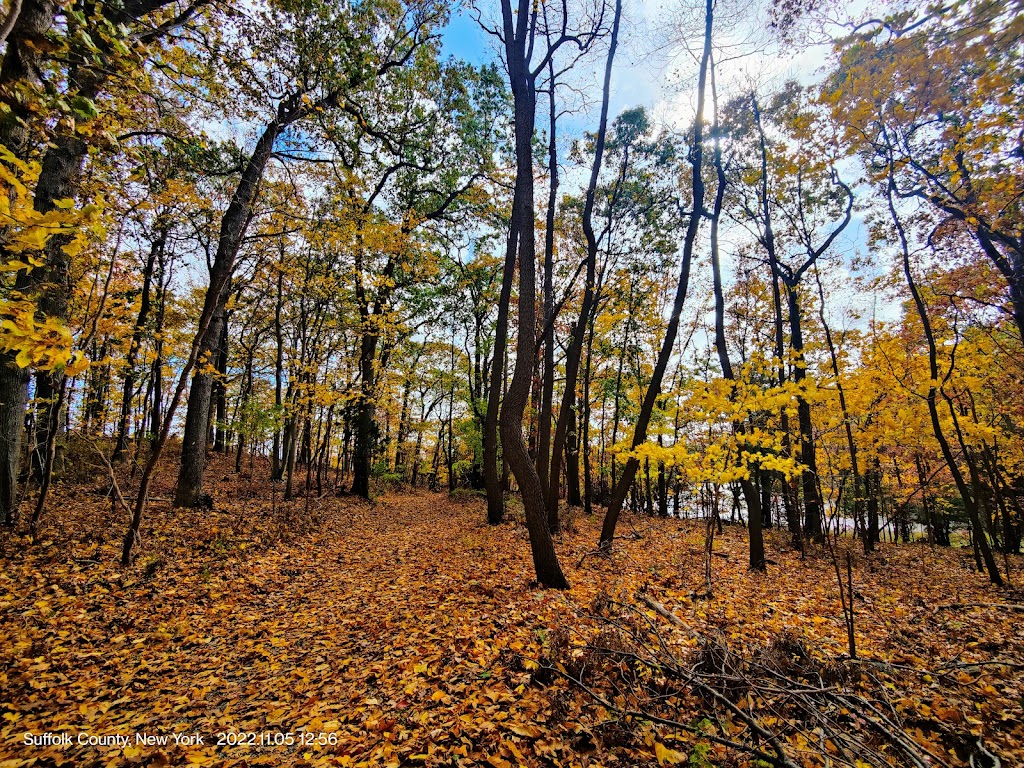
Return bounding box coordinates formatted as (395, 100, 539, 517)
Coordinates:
(539, 595, 974, 768)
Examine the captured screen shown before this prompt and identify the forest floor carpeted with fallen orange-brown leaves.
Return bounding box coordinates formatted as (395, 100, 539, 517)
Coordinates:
(0, 450, 1024, 768)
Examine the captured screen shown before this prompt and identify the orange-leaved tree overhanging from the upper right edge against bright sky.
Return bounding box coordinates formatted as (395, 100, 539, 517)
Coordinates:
(826, 0, 1024, 337)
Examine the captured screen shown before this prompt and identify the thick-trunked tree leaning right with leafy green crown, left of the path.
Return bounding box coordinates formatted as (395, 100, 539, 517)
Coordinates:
(174, 2, 442, 507)
